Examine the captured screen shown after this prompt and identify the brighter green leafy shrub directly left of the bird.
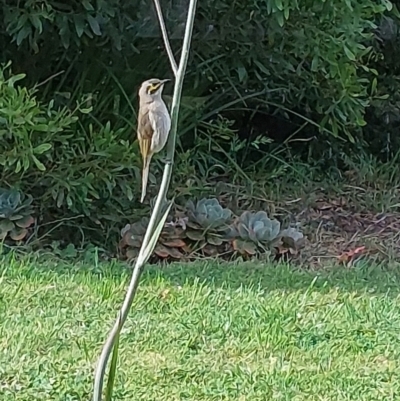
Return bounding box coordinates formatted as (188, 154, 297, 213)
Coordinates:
(0, 65, 139, 219)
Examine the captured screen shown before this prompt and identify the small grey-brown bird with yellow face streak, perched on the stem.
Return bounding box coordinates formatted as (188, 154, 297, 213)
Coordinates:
(137, 78, 171, 203)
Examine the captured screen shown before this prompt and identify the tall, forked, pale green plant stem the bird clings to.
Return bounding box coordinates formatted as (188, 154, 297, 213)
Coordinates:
(93, 0, 197, 401)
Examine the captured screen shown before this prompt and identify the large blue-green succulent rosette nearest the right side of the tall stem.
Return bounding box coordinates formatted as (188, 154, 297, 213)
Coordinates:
(186, 198, 232, 255)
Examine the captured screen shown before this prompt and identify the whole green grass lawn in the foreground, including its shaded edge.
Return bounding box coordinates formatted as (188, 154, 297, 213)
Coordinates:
(0, 255, 400, 401)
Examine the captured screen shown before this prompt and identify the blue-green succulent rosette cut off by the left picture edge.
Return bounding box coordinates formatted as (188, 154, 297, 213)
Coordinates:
(0, 189, 35, 241)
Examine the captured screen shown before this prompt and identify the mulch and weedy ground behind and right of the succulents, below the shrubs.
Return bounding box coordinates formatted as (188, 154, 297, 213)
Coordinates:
(208, 183, 400, 267)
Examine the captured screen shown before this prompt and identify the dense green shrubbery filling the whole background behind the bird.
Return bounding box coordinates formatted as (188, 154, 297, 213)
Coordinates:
(0, 0, 400, 250)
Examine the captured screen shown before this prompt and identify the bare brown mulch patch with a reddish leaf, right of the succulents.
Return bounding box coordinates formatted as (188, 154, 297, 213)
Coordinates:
(276, 195, 400, 267)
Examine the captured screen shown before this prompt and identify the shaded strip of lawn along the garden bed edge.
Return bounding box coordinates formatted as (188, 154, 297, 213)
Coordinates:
(0, 255, 400, 296)
